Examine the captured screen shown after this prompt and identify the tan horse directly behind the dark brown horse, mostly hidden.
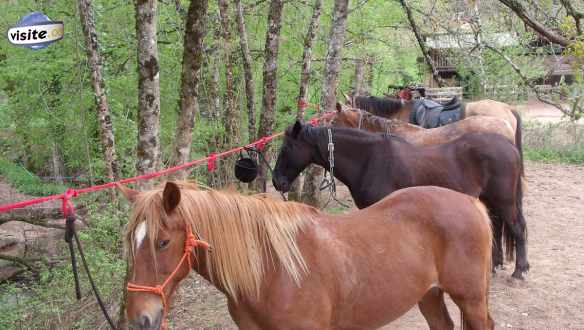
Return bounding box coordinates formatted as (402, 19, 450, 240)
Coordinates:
(330, 103, 515, 145)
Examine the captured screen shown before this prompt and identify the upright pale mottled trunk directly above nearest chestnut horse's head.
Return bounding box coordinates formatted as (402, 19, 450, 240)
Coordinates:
(136, 0, 160, 180)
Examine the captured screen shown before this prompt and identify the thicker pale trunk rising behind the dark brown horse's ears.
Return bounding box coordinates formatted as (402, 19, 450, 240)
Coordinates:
(302, 0, 349, 207)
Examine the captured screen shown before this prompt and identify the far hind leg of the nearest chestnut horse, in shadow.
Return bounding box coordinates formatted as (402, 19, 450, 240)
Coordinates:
(418, 287, 454, 330)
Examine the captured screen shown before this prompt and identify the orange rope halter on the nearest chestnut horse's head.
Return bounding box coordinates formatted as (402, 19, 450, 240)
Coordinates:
(127, 224, 211, 329)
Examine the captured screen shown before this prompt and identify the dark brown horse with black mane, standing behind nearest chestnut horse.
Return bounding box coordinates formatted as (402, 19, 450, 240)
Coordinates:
(273, 122, 529, 278)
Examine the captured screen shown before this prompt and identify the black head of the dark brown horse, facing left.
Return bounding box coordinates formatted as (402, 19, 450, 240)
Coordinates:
(272, 121, 318, 192)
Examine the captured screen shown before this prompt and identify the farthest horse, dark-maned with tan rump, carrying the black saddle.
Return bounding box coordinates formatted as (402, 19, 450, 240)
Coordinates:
(344, 94, 522, 153)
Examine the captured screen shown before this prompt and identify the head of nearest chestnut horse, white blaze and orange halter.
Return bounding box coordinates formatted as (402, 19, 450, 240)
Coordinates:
(120, 182, 204, 329)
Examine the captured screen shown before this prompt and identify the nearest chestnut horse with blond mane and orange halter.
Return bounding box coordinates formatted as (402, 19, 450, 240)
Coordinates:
(123, 182, 494, 330)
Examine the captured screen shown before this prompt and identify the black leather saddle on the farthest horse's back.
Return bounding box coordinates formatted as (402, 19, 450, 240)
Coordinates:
(410, 96, 464, 128)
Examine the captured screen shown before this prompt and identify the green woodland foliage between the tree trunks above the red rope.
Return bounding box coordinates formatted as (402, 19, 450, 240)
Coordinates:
(0, 0, 419, 183)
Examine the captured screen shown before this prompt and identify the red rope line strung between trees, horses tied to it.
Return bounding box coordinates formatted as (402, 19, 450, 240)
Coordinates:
(0, 113, 331, 217)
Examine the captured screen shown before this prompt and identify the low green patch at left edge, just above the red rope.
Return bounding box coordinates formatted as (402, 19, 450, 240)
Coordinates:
(0, 158, 65, 196)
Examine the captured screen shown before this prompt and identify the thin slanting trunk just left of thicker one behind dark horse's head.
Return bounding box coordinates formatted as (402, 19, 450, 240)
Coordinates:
(288, 0, 322, 201)
